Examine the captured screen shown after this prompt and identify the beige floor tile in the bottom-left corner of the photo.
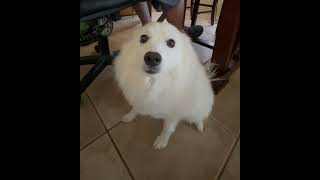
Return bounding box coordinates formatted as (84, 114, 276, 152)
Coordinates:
(80, 135, 131, 180)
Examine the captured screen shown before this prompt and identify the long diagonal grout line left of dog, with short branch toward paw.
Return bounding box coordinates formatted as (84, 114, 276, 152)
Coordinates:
(86, 93, 135, 180)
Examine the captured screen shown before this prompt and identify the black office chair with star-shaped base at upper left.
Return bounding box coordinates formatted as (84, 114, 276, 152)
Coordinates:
(80, 0, 144, 99)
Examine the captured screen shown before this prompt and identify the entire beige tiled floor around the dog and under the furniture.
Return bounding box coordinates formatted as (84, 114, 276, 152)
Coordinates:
(80, 10, 240, 180)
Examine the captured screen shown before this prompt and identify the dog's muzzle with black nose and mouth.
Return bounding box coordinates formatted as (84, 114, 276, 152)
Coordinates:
(144, 51, 162, 74)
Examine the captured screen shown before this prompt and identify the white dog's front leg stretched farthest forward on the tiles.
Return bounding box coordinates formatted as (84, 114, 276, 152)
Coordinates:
(153, 120, 178, 149)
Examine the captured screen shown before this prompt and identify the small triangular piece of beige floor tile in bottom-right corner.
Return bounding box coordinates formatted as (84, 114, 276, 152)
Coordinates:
(220, 141, 240, 180)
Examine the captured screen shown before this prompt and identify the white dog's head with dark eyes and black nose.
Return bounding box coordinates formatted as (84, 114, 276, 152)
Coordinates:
(133, 23, 190, 75)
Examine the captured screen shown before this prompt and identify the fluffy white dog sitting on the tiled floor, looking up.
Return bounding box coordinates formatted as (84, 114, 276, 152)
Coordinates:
(114, 23, 214, 149)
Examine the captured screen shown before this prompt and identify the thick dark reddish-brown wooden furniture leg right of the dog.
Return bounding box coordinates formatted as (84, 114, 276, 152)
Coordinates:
(211, 0, 240, 93)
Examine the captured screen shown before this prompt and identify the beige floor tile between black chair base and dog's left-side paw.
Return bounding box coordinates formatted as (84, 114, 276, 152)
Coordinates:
(87, 67, 130, 129)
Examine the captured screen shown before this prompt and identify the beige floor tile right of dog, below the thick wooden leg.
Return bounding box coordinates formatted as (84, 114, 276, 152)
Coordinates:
(213, 69, 240, 136)
